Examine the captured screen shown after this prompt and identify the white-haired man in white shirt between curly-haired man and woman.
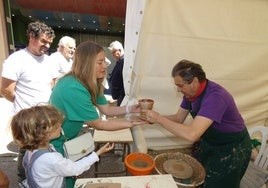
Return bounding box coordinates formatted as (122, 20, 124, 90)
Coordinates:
(49, 36, 76, 77)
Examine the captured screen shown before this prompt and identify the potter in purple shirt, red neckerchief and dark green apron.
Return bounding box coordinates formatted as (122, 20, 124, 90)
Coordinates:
(142, 60, 251, 188)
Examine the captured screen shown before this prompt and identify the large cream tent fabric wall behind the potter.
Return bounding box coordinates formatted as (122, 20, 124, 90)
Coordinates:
(123, 0, 268, 152)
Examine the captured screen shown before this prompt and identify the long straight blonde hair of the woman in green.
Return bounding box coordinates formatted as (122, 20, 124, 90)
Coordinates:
(66, 41, 104, 105)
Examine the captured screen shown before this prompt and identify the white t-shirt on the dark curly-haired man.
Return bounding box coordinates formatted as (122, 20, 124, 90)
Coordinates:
(2, 48, 57, 113)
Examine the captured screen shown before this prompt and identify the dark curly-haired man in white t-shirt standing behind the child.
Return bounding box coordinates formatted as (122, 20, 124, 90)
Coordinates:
(1, 21, 57, 185)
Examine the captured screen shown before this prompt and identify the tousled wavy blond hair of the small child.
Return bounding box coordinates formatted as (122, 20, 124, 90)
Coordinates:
(11, 105, 64, 150)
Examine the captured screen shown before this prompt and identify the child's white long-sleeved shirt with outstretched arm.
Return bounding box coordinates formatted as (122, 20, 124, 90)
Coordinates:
(24, 147, 99, 188)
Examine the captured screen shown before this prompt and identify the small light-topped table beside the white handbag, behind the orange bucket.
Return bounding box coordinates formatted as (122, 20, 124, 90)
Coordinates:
(93, 129, 133, 177)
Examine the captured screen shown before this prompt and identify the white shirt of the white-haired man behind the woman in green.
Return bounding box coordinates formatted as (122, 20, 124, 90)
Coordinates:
(49, 52, 73, 77)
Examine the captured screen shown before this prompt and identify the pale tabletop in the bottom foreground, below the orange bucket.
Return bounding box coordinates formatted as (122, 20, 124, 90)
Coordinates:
(74, 174, 177, 188)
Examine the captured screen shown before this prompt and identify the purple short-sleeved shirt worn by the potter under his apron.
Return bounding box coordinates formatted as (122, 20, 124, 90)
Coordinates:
(181, 81, 245, 133)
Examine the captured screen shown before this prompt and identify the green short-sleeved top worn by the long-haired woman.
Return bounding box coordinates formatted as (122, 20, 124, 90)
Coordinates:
(50, 75, 107, 154)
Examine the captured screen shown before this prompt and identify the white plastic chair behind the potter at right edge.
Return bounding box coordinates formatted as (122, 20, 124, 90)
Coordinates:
(248, 126, 268, 170)
